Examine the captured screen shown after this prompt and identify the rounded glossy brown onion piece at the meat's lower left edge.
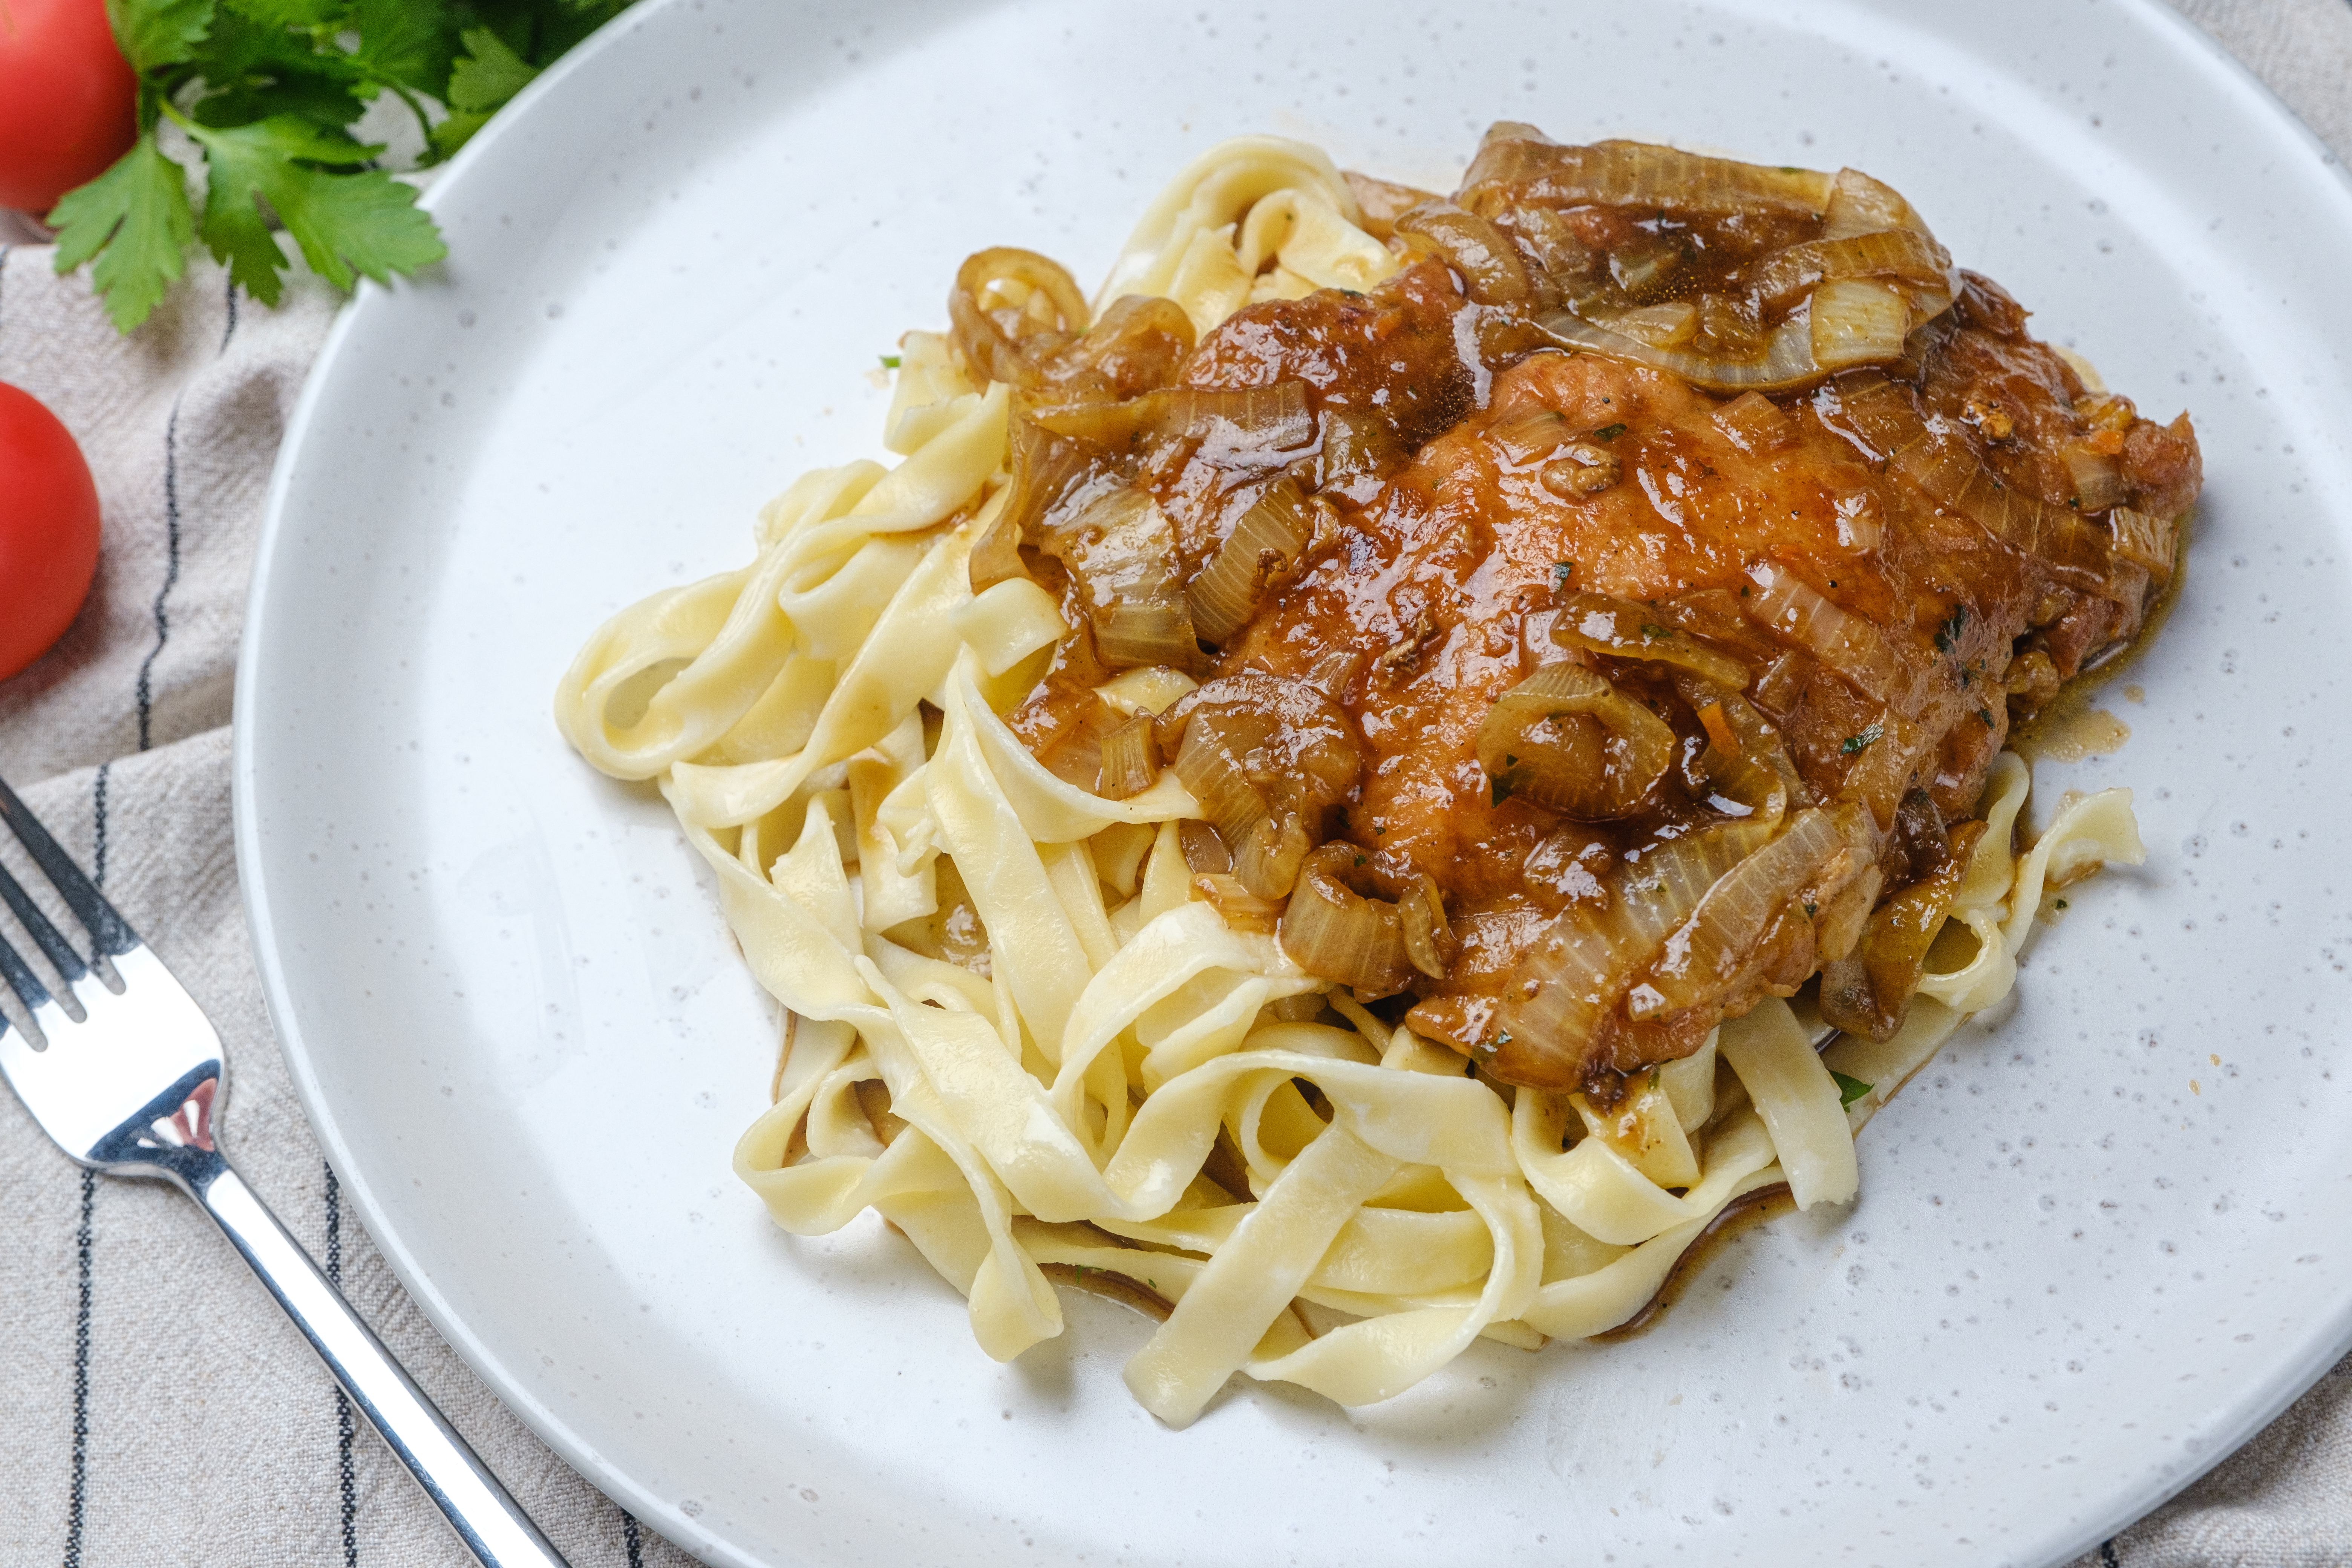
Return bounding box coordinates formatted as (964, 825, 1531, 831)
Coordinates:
(1159, 670, 1364, 898)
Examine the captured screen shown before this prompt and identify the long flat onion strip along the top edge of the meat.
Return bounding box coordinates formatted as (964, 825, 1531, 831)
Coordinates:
(1463, 135, 1830, 219)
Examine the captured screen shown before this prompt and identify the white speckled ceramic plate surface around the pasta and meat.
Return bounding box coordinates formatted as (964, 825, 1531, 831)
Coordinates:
(237, 0, 2352, 1563)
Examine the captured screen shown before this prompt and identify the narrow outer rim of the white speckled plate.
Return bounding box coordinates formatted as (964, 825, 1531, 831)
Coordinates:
(231, 0, 2352, 1568)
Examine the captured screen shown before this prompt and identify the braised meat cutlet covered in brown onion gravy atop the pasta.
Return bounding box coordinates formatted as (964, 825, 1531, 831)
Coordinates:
(978, 127, 2202, 1098)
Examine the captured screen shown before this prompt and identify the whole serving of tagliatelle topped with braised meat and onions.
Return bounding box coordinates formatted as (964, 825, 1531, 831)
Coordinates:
(555, 125, 2197, 1425)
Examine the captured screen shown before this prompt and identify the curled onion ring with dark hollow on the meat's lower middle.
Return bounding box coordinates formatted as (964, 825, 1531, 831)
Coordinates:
(1477, 663, 1675, 823)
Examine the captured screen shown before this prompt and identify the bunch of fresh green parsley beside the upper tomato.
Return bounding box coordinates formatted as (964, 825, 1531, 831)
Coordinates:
(49, 0, 628, 331)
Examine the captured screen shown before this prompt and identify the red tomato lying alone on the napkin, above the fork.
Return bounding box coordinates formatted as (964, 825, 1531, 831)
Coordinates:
(0, 383, 99, 679)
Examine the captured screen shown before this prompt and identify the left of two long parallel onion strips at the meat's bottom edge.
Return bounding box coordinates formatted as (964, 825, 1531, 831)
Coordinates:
(1482, 823, 1769, 1089)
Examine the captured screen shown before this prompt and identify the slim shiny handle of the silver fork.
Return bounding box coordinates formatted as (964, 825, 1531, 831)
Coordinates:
(188, 1159, 567, 1568)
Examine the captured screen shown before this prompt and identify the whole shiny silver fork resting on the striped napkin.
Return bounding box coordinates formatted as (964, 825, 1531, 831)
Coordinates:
(0, 781, 565, 1568)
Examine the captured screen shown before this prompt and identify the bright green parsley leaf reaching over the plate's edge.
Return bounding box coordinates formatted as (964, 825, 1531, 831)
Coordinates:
(188, 115, 449, 306)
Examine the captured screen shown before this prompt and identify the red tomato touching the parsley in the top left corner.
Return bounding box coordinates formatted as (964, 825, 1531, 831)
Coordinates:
(0, 0, 139, 216)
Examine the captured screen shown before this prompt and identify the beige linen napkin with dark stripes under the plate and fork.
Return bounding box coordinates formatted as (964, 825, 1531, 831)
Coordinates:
(0, 0, 2352, 1568)
